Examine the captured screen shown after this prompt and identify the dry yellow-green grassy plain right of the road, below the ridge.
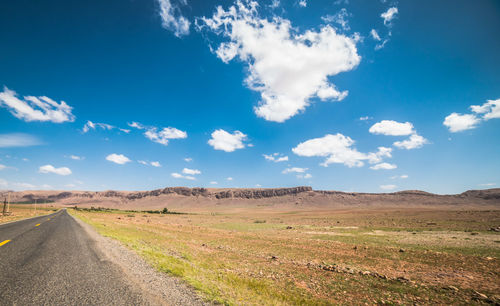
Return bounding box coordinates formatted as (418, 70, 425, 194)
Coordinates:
(72, 208, 500, 305)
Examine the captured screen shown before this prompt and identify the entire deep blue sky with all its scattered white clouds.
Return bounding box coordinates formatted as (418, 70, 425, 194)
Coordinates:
(0, 0, 500, 193)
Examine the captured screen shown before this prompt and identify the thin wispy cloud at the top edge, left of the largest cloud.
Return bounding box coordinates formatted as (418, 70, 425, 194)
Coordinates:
(158, 0, 191, 37)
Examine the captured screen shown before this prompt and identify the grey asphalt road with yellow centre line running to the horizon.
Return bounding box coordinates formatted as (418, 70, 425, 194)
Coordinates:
(0, 210, 152, 305)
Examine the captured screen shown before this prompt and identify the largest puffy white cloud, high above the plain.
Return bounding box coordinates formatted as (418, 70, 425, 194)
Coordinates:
(197, 1, 361, 122)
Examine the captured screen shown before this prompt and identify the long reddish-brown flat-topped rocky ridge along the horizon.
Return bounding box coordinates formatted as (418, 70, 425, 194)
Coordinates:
(0, 186, 500, 210)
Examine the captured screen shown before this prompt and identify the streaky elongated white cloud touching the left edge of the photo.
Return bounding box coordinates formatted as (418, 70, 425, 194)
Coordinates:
(0, 87, 75, 123)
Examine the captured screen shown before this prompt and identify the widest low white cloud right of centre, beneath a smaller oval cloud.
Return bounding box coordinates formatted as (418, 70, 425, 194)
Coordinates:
(292, 133, 392, 167)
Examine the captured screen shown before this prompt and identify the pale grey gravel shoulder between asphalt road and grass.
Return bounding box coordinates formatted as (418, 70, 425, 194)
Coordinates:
(74, 214, 211, 305)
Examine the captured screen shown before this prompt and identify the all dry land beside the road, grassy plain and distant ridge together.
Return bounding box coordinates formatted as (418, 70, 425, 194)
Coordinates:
(2, 187, 500, 305)
